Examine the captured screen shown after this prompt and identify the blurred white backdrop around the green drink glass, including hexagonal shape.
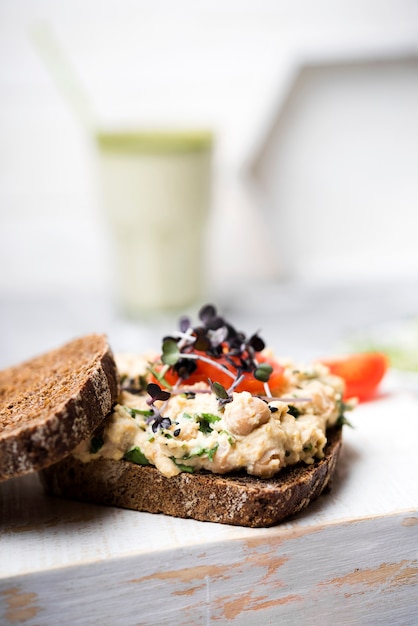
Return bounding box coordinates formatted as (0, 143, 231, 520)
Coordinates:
(0, 0, 418, 360)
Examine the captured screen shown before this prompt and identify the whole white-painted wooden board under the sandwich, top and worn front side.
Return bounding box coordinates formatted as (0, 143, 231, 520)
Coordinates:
(0, 391, 418, 626)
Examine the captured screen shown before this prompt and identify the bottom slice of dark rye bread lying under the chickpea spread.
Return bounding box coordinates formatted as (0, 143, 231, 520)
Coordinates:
(41, 428, 342, 528)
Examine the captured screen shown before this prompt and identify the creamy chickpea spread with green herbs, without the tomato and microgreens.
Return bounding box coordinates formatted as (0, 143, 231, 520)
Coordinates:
(74, 356, 343, 478)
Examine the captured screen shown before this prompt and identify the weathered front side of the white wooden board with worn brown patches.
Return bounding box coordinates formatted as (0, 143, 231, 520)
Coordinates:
(0, 514, 418, 626)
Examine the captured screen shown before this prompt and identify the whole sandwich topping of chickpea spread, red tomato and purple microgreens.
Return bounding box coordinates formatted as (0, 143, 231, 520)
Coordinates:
(74, 305, 347, 478)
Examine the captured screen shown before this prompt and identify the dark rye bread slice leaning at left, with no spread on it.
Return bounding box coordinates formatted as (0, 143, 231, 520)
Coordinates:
(0, 334, 118, 480)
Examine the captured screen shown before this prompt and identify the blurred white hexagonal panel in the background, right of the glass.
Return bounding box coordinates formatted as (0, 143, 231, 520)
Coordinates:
(251, 59, 418, 279)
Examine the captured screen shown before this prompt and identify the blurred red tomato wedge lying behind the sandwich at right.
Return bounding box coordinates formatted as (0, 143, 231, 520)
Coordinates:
(321, 352, 389, 401)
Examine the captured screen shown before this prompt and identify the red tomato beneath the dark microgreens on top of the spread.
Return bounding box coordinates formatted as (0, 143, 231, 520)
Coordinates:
(153, 355, 286, 395)
